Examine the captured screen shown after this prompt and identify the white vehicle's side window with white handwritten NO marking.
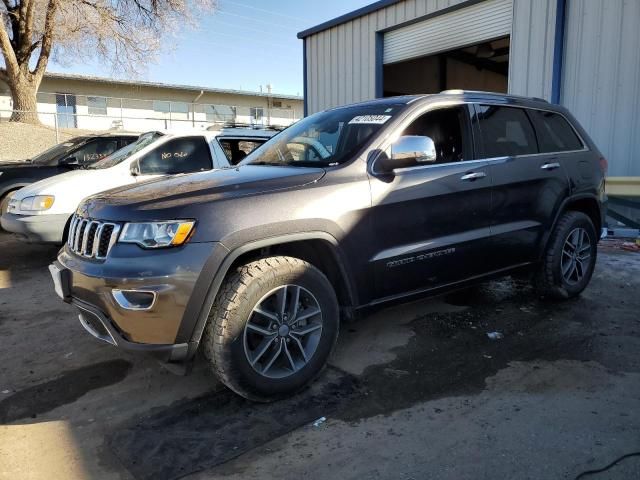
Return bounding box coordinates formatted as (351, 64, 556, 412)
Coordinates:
(140, 137, 212, 175)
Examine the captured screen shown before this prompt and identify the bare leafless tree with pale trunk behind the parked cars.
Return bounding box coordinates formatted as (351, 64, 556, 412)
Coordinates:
(0, 0, 216, 123)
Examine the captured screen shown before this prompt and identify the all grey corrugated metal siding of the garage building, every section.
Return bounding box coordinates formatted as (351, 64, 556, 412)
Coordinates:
(305, 0, 640, 176)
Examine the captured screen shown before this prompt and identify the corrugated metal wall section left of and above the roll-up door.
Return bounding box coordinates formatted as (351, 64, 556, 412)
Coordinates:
(305, 0, 463, 113)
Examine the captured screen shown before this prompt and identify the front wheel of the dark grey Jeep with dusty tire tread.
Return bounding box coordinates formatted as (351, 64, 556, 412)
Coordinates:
(203, 257, 340, 402)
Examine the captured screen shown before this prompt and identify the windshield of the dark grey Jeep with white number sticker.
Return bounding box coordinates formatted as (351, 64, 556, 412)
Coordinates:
(239, 103, 405, 167)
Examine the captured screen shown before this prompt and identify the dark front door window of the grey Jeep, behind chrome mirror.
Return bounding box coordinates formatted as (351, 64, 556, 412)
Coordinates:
(402, 106, 472, 163)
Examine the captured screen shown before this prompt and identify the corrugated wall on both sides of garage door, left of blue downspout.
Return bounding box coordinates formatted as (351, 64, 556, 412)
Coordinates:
(305, 0, 556, 113)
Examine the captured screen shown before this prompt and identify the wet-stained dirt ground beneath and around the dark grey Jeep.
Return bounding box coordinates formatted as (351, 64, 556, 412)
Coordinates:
(0, 233, 640, 480)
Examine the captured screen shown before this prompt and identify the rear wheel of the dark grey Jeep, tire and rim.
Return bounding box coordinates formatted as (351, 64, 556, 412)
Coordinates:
(535, 211, 598, 300)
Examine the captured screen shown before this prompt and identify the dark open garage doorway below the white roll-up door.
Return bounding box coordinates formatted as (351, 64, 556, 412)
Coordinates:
(383, 37, 509, 97)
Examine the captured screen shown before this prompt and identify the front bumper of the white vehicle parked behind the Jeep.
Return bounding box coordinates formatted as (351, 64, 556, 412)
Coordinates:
(0, 212, 71, 245)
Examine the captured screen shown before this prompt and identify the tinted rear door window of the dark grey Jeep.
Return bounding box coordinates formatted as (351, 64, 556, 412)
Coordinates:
(477, 105, 538, 158)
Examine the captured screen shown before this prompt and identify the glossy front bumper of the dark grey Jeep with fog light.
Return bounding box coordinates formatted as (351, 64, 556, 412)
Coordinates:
(50, 243, 226, 362)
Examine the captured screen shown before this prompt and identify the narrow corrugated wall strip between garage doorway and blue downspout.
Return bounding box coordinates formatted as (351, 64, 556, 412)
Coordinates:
(509, 0, 557, 100)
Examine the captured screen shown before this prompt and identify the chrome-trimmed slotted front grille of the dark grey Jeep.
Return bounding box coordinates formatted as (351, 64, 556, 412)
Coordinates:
(67, 215, 120, 260)
